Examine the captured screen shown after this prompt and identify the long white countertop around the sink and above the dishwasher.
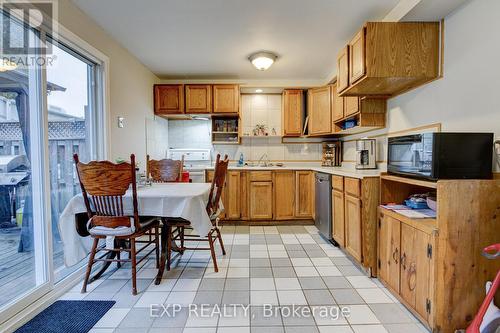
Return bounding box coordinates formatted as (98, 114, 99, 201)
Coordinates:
(203, 162, 381, 179)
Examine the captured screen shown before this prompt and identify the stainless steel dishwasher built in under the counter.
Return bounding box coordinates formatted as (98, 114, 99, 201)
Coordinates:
(314, 172, 332, 241)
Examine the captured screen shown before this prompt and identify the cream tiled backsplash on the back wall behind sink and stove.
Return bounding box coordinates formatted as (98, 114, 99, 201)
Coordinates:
(168, 94, 321, 161)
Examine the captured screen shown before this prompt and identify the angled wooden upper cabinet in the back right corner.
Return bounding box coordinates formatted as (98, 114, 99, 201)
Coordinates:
(307, 86, 332, 135)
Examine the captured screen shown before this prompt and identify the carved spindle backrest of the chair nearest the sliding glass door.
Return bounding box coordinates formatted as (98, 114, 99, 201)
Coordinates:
(73, 154, 139, 230)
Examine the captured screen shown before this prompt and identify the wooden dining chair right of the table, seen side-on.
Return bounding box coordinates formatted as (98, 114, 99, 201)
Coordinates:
(160, 155, 229, 272)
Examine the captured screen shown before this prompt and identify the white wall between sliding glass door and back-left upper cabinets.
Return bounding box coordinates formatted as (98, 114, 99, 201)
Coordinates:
(58, 0, 166, 166)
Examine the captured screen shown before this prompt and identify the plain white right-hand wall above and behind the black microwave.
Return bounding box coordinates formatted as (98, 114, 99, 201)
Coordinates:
(344, 0, 500, 171)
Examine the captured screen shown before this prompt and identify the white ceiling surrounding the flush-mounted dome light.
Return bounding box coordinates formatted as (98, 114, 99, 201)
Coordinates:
(73, 0, 399, 81)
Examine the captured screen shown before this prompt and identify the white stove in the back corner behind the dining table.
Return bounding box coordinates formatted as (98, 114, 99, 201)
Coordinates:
(167, 148, 212, 183)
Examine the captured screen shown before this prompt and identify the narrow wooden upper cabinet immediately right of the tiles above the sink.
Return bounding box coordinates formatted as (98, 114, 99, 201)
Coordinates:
(283, 89, 304, 136)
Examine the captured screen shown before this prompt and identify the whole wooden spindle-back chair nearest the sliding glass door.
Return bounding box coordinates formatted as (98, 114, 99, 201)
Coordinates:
(73, 154, 159, 295)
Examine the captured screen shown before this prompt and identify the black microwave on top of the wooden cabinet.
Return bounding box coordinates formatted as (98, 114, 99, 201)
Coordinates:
(387, 132, 493, 180)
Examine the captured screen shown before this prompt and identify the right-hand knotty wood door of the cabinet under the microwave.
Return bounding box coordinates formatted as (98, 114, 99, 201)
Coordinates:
(400, 224, 431, 320)
